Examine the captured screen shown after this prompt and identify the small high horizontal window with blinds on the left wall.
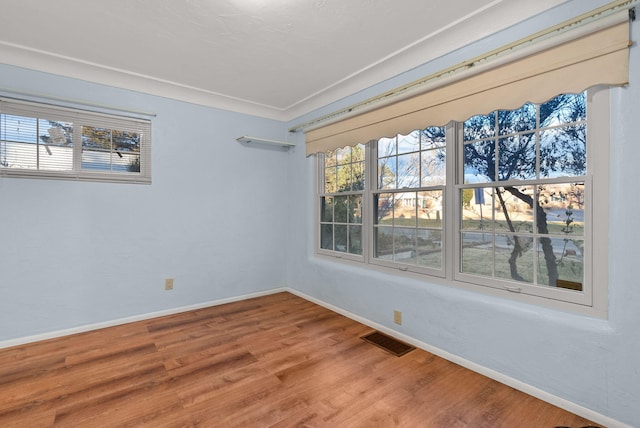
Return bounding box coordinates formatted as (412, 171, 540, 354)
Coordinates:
(0, 100, 151, 183)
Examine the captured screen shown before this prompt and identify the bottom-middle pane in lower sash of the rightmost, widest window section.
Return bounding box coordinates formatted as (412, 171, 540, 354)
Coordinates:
(495, 235, 533, 283)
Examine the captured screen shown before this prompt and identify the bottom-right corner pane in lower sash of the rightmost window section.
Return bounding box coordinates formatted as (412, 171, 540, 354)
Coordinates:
(537, 238, 584, 291)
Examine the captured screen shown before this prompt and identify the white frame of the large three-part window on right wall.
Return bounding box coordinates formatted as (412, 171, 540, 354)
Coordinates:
(314, 87, 610, 318)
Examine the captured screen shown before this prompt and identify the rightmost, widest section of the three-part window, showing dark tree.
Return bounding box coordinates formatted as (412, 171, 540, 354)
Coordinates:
(459, 93, 589, 291)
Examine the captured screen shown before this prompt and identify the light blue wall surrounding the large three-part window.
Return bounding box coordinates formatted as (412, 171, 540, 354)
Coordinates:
(287, 0, 640, 426)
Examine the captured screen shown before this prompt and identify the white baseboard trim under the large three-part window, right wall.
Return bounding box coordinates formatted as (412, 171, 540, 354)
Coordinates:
(286, 288, 632, 428)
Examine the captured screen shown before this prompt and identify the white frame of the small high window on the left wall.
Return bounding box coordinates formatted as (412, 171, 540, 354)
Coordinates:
(0, 98, 151, 184)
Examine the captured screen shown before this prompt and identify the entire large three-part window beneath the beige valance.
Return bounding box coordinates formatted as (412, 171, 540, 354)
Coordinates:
(318, 90, 608, 306)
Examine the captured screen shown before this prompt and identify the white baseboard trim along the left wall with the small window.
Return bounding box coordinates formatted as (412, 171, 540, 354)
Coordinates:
(0, 288, 289, 349)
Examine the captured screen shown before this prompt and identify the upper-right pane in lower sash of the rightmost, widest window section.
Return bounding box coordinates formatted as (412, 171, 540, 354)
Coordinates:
(537, 183, 584, 236)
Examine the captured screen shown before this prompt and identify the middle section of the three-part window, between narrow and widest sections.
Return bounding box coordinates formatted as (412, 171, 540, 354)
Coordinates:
(372, 127, 446, 274)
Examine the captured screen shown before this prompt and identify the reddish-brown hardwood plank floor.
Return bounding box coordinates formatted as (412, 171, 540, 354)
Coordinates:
(0, 293, 592, 428)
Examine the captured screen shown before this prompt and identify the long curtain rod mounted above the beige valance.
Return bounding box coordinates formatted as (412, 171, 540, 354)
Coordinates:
(289, 0, 640, 132)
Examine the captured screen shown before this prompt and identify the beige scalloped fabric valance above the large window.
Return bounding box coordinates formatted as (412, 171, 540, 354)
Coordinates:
(306, 12, 630, 156)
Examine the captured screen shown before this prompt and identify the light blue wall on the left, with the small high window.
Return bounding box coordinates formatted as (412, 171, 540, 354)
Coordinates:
(0, 65, 291, 341)
